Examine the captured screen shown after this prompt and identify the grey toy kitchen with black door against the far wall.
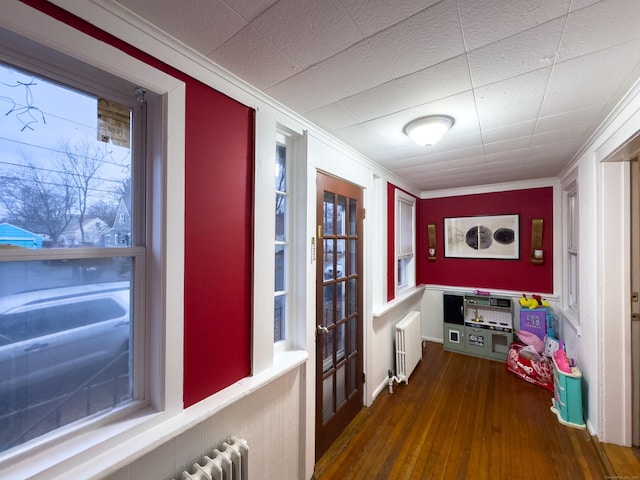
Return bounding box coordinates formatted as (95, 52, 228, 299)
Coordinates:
(443, 292, 513, 361)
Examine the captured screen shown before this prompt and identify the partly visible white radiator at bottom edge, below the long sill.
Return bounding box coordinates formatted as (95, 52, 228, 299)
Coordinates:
(182, 437, 249, 480)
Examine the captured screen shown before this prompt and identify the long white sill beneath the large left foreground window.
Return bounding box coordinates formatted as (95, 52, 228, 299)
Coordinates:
(0, 350, 308, 479)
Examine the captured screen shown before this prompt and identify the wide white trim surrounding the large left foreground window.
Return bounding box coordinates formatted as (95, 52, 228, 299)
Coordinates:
(0, 2, 185, 478)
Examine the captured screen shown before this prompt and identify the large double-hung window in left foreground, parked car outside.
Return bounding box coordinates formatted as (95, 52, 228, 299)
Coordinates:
(0, 57, 146, 451)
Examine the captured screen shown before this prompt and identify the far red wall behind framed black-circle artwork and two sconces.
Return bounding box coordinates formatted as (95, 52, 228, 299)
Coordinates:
(416, 187, 553, 293)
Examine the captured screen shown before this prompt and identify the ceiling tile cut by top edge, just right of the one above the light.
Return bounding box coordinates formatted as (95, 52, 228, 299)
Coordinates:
(458, 0, 571, 51)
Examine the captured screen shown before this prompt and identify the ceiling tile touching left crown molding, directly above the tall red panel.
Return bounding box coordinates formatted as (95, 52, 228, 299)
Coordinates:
(209, 26, 300, 90)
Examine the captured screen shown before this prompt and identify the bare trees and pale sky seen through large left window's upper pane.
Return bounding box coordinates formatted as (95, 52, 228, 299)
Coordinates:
(0, 62, 131, 248)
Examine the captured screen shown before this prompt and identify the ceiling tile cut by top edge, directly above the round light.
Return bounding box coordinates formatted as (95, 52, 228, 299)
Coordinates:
(368, 0, 464, 78)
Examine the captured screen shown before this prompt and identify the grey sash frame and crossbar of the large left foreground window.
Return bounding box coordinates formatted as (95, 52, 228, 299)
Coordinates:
(0, 44, 150, 453)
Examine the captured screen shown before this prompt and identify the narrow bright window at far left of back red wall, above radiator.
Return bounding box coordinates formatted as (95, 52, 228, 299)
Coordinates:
(395, 189, 416, 293)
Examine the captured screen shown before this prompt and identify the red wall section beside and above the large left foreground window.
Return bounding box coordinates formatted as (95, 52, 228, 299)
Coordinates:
(22, 0, 254, 406)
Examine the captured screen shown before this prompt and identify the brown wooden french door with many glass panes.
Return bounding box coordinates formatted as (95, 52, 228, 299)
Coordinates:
(316, 172, 364, 459)
